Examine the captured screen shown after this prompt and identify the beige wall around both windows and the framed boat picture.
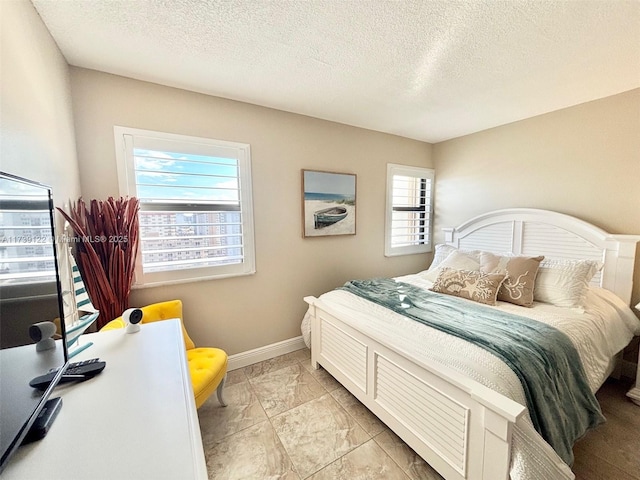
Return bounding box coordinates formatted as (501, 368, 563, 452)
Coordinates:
(71, 68, 432, 354)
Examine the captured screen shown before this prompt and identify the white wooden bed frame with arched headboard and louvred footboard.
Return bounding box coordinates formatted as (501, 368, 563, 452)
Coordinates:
(305, 209, 640, 480)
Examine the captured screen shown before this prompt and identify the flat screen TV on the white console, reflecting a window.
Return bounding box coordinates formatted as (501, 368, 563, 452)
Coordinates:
(0, 172, 68, 472)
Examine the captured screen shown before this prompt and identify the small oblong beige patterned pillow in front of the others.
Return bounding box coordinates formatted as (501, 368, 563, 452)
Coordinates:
(431, 267, 506, 305)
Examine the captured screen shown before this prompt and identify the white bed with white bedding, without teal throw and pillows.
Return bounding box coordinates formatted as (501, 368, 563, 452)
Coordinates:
(303, 209, 640, 480)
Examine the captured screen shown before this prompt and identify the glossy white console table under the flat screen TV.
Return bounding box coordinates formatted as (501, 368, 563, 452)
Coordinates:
(2, 320, 207, 480)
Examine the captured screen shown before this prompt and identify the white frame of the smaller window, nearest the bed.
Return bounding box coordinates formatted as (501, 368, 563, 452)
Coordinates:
(384, 163, 435, 257)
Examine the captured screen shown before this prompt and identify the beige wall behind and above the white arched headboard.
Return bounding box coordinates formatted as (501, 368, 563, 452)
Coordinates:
(433, 89, 640, 308)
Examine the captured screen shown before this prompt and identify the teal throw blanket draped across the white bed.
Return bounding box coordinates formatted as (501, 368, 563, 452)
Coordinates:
(341, 279, 604, 465)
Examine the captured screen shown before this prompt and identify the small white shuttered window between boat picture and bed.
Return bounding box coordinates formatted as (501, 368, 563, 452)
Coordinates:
(384, 163, 434, 257)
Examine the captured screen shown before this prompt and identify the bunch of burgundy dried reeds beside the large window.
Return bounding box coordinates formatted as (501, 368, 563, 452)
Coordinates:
(58, 197, 140, 328)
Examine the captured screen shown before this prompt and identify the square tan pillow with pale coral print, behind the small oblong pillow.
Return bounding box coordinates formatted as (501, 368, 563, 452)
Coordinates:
(480, 252, 544, 307)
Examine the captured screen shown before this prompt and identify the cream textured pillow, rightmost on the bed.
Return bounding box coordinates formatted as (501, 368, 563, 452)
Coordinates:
(533, 260, 602, 308)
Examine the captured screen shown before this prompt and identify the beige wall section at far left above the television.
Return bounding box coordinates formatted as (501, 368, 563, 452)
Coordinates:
(0, 0, 80, 206)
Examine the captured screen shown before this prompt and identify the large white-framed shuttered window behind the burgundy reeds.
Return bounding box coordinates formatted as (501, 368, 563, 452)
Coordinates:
(114, 127, 255, 285)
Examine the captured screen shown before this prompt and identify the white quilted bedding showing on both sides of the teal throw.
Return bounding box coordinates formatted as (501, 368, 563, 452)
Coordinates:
(302, 274, 640, 480)
